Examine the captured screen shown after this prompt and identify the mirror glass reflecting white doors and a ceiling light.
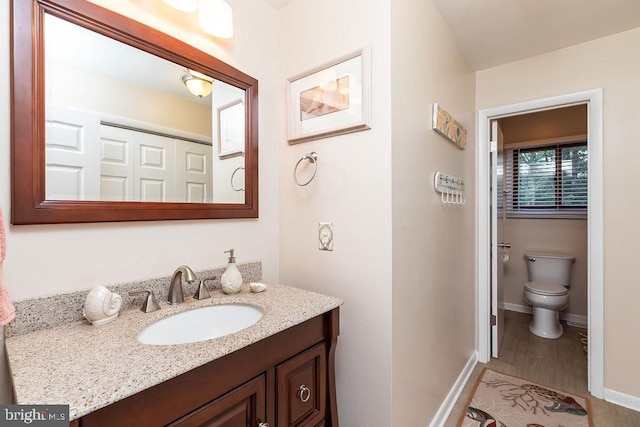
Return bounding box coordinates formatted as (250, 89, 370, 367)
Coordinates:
(45, 14, 246, 203)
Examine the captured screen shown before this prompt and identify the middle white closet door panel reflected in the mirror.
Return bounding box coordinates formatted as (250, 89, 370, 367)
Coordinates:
(133, 132, 176, 202)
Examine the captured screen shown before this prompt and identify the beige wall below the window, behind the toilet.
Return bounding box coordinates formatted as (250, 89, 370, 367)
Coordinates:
(502, 218, 587, 321)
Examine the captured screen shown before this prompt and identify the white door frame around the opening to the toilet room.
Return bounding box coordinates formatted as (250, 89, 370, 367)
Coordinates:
(476, 89, 604, 399)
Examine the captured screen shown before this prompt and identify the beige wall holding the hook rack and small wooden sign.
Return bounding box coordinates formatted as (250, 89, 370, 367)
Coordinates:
(388, 0, 476, 426)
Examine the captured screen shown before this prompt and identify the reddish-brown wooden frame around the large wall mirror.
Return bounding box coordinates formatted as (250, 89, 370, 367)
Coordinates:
(11, 0, 258, 225)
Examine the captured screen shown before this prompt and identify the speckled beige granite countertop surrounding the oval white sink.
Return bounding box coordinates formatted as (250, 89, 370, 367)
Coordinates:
(5, 284, 343, 419)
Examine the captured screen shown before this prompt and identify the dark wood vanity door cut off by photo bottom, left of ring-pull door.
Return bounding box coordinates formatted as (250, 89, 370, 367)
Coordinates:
(169, 375, 266, 427)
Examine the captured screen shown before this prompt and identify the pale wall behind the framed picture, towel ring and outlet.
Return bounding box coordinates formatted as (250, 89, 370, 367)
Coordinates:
(278, 0, 392, 426)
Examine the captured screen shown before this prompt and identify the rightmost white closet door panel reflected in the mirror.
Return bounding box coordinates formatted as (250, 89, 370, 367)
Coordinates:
(176, 140, 213, 203)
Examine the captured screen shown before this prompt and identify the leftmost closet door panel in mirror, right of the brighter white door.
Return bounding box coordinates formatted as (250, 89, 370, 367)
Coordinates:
(100, 125, 134, 200)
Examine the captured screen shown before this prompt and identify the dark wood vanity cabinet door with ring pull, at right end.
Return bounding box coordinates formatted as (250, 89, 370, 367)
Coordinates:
(276, 343, 327, 427)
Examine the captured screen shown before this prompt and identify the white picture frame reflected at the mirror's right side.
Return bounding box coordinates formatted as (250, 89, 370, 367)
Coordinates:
(218, 99, 245, 159)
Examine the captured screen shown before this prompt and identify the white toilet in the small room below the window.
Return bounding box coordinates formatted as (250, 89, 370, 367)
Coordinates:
(524, 252, 575, 339)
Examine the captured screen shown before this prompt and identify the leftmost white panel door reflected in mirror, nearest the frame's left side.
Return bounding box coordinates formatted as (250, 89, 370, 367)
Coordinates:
(45, 105, 100, 200)
